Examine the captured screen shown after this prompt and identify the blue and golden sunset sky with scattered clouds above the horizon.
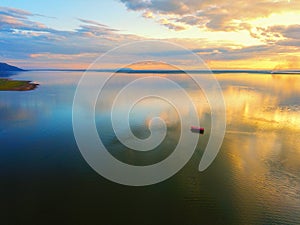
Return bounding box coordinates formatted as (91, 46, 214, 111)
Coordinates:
(0, 0, 300, 70)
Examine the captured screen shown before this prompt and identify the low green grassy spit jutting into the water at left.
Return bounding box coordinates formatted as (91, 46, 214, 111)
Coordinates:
(0, 78, 38, 91)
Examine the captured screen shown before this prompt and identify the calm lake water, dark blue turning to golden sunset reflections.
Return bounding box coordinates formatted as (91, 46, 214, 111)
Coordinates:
(0, 72, 300, 225)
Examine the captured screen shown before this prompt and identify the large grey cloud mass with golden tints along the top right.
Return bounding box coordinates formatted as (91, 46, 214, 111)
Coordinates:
(120, 0, 300, 31)
